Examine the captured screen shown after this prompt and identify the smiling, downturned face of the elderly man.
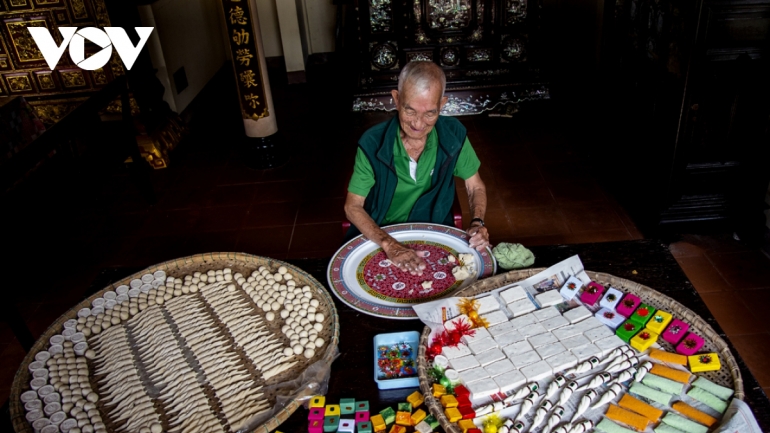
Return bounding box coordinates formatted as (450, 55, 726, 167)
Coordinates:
(391, 82, 448, 140)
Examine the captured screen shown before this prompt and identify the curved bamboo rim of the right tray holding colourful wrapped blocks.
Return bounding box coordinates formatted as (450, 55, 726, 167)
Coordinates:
(417, 268, 745, 433)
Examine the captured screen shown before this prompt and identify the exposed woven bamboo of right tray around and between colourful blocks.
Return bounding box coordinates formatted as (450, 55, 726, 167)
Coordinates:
(417, 268, 744, 433)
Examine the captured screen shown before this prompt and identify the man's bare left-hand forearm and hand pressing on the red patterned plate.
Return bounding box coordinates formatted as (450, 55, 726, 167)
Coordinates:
(345, 192, 426, 275)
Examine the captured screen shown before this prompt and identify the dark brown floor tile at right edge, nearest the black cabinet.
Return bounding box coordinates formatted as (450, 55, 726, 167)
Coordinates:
(707, 250, 770, 290)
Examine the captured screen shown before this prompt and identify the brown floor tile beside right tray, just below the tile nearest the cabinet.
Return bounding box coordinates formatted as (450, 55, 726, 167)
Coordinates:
(700, 292, 766, 337)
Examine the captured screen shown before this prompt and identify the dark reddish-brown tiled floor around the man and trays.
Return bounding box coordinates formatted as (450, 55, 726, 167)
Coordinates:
(0, 65, 770, 412)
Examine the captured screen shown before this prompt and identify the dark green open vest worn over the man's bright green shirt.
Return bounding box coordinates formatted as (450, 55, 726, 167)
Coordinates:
(346, 116, 467, 239)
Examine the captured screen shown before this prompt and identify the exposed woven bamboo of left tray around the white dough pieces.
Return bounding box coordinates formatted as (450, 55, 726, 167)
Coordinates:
(9, 252, 339, 433)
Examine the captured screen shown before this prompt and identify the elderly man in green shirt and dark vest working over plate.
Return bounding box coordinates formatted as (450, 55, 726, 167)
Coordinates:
(345, 62, 489, 275)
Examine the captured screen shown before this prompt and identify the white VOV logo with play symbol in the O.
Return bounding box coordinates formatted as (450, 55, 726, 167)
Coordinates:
(27, 27, 154, 71)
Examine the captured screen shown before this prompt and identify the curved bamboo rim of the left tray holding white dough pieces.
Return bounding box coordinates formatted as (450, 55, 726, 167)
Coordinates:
(9, 252, 340, 433)
